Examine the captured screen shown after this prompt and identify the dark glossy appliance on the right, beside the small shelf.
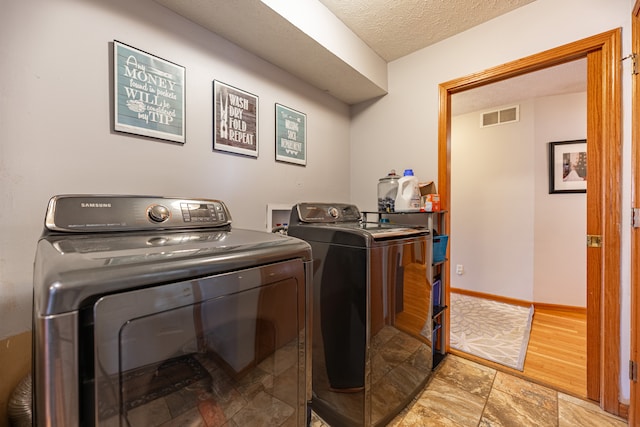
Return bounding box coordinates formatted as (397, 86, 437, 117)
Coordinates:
(288, 203, 433, 427)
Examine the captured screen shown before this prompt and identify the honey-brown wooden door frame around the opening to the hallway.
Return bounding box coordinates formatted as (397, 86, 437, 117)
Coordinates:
(438, 28, 621, 414)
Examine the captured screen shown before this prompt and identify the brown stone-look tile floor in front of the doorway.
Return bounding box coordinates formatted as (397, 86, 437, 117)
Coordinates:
(311, 355, 627, 427)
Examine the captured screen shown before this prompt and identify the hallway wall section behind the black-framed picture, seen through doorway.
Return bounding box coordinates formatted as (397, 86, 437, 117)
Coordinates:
(533, 93, 588, 307)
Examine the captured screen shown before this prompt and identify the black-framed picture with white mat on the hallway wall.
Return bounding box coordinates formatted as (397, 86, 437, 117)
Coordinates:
(549, 139, 587, 194)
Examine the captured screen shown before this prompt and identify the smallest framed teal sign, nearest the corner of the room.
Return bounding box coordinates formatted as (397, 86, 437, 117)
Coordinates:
(276, 104, 307, 165)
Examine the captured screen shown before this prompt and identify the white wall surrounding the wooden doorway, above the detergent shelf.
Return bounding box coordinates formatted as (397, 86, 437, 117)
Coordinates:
(351, 0, 633, 399)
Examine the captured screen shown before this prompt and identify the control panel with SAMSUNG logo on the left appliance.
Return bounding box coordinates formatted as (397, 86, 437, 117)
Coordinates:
(45, 195, 231, 233)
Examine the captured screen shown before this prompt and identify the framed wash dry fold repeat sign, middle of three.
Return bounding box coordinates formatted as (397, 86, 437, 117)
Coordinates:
(213, 80, 258, 157)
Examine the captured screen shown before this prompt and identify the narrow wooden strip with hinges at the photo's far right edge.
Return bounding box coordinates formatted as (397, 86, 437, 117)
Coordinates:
(629, 0, 640, 426)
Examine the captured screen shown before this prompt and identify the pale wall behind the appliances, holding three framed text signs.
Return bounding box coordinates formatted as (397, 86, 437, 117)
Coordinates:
(0, 0, 350, 338)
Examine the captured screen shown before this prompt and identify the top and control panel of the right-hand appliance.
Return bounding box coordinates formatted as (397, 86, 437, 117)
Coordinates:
(287, 203, 429, 247)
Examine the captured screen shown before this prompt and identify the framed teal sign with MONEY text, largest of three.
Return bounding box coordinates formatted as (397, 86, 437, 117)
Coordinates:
(113, 40, 185, 143)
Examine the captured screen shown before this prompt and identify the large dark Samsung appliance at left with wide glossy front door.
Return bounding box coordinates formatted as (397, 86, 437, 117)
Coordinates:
(33, 195, 311, 427)
